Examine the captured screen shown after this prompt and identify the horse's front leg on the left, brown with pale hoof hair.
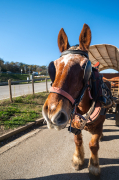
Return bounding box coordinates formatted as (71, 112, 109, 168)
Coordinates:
(72, 134, 84, 170)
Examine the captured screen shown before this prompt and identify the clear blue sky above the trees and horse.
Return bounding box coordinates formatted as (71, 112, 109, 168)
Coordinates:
(0, 0, 119, 72)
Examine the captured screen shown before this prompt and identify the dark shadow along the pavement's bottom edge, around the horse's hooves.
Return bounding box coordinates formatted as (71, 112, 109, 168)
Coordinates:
(9, 158, 119, 180)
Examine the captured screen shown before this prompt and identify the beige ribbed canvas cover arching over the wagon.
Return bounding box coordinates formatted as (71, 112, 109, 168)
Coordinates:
(88, 44, 119, 71)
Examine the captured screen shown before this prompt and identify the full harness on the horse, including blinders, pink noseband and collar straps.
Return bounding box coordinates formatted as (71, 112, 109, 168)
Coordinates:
(48, 47, 112, 135)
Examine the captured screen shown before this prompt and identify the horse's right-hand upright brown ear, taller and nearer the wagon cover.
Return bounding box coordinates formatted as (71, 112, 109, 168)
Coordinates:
(79, 24, 91, 51)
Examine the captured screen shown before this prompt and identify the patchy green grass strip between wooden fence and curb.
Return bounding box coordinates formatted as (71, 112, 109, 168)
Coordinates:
(0, 92, 49, 129)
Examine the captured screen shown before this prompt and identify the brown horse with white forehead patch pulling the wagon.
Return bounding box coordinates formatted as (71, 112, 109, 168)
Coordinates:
(43, 24, 110, 175)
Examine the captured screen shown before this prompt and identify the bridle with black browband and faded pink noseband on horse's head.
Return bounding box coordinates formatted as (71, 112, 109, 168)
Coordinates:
(49, 47, 95, 135)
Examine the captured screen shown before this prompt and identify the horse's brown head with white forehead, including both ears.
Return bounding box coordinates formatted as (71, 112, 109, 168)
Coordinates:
(42, 24, 91, 130)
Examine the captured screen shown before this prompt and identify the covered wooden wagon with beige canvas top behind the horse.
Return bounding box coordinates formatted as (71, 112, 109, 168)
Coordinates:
(89, 44, 119, 126)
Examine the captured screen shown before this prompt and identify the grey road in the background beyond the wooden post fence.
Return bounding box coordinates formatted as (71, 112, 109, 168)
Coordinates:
(0, 82, 51, 100)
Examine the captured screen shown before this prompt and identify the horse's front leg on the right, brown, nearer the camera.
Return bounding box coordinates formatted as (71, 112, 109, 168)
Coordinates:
(88, 133, 102, 176)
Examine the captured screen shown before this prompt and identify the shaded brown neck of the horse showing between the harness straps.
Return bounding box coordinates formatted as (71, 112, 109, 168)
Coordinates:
(77, 89, 91, 114)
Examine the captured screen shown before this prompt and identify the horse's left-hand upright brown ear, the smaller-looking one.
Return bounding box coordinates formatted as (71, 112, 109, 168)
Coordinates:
(58, 28, 70, 52)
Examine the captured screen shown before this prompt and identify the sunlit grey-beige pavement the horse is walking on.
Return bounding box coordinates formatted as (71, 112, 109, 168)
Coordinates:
(0, 115, 119, 180)
